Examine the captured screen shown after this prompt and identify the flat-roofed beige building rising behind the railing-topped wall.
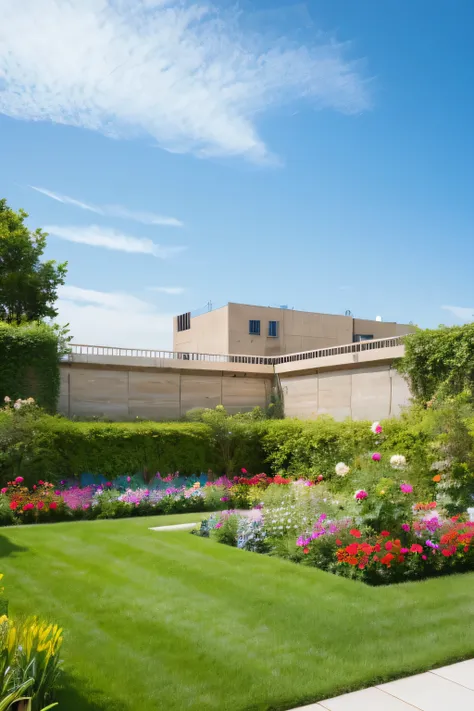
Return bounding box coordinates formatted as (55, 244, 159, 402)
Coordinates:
(173, 303, 415, 356)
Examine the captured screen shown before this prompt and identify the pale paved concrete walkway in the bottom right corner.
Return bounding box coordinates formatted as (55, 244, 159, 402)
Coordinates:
(293, 659, 474, 711)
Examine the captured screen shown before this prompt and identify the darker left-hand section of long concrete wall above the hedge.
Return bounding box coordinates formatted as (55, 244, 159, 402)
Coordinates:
(59, 363, 273, 421)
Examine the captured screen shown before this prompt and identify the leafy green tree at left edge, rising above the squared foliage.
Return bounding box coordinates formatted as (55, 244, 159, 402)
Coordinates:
(0, 199, 67, 324)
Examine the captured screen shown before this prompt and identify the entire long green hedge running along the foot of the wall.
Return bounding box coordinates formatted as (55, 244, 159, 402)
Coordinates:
(0, 408, 440, 484)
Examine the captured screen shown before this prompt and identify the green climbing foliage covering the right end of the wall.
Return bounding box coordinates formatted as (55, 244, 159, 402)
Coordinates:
(397, 323, 474, 402)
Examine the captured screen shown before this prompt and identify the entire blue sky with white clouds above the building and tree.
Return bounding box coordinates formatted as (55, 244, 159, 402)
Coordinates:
(0, 0, 474, 348)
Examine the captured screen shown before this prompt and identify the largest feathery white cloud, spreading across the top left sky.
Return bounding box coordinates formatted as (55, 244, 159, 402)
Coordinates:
(0, 0, 370, 161)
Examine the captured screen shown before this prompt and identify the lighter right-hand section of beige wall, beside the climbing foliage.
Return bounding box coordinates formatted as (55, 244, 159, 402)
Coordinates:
(280, 364, 411, 420)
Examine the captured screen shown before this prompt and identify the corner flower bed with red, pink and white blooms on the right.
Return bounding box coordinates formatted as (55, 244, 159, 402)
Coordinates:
(194, 423, 474, 585)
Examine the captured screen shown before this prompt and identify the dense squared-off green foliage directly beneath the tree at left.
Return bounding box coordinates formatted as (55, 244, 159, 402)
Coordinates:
(0, 322, 61, 412)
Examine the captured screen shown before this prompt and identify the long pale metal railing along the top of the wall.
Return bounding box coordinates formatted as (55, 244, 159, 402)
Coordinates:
(64, 336, 402, 366)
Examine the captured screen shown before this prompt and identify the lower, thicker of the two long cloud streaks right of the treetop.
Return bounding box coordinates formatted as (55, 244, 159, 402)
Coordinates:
(44, 225, 186, 259)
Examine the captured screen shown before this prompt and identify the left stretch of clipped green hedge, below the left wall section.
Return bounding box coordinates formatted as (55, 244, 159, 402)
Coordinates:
(0, 410, 214, 484)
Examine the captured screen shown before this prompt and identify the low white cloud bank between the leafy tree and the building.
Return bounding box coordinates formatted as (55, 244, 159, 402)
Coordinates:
(56, 286, 173, 350)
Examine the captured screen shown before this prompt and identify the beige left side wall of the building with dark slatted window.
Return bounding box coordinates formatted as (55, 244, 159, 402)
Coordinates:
(173, 306, 230, 354)
